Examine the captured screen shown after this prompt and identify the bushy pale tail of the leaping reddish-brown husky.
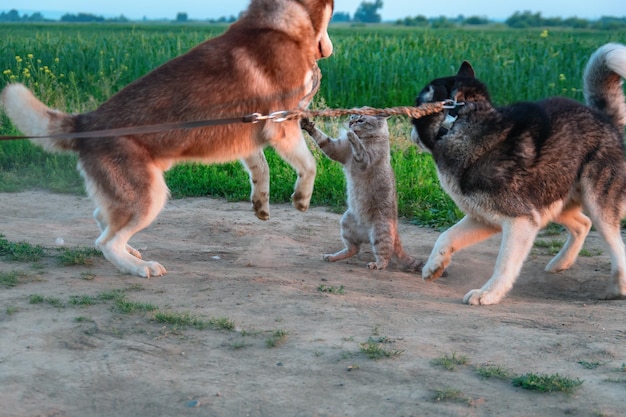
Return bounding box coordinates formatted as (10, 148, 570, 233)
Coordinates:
(0, 83, 76, 152)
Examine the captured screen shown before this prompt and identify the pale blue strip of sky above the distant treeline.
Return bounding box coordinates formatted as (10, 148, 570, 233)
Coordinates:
(9, 0, 626, 21)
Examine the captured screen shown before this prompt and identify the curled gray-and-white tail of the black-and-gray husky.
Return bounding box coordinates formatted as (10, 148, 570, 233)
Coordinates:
(583, 43, 626, 132)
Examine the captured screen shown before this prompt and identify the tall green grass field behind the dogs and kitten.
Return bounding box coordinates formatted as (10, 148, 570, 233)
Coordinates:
(0, 23, 626, 227)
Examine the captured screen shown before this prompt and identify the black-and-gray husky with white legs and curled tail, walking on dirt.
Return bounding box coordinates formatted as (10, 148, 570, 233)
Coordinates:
(411, 43, 626, 304)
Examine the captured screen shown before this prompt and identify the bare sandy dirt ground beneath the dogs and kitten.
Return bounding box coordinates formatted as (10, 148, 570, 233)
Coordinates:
(0, 192, 626, 417)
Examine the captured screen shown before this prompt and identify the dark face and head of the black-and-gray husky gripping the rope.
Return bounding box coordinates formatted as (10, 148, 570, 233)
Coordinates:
(411, 61, 490, 152)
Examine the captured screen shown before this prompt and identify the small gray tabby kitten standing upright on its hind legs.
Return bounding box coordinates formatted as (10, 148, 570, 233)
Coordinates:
(300, 115, 422, 271)
